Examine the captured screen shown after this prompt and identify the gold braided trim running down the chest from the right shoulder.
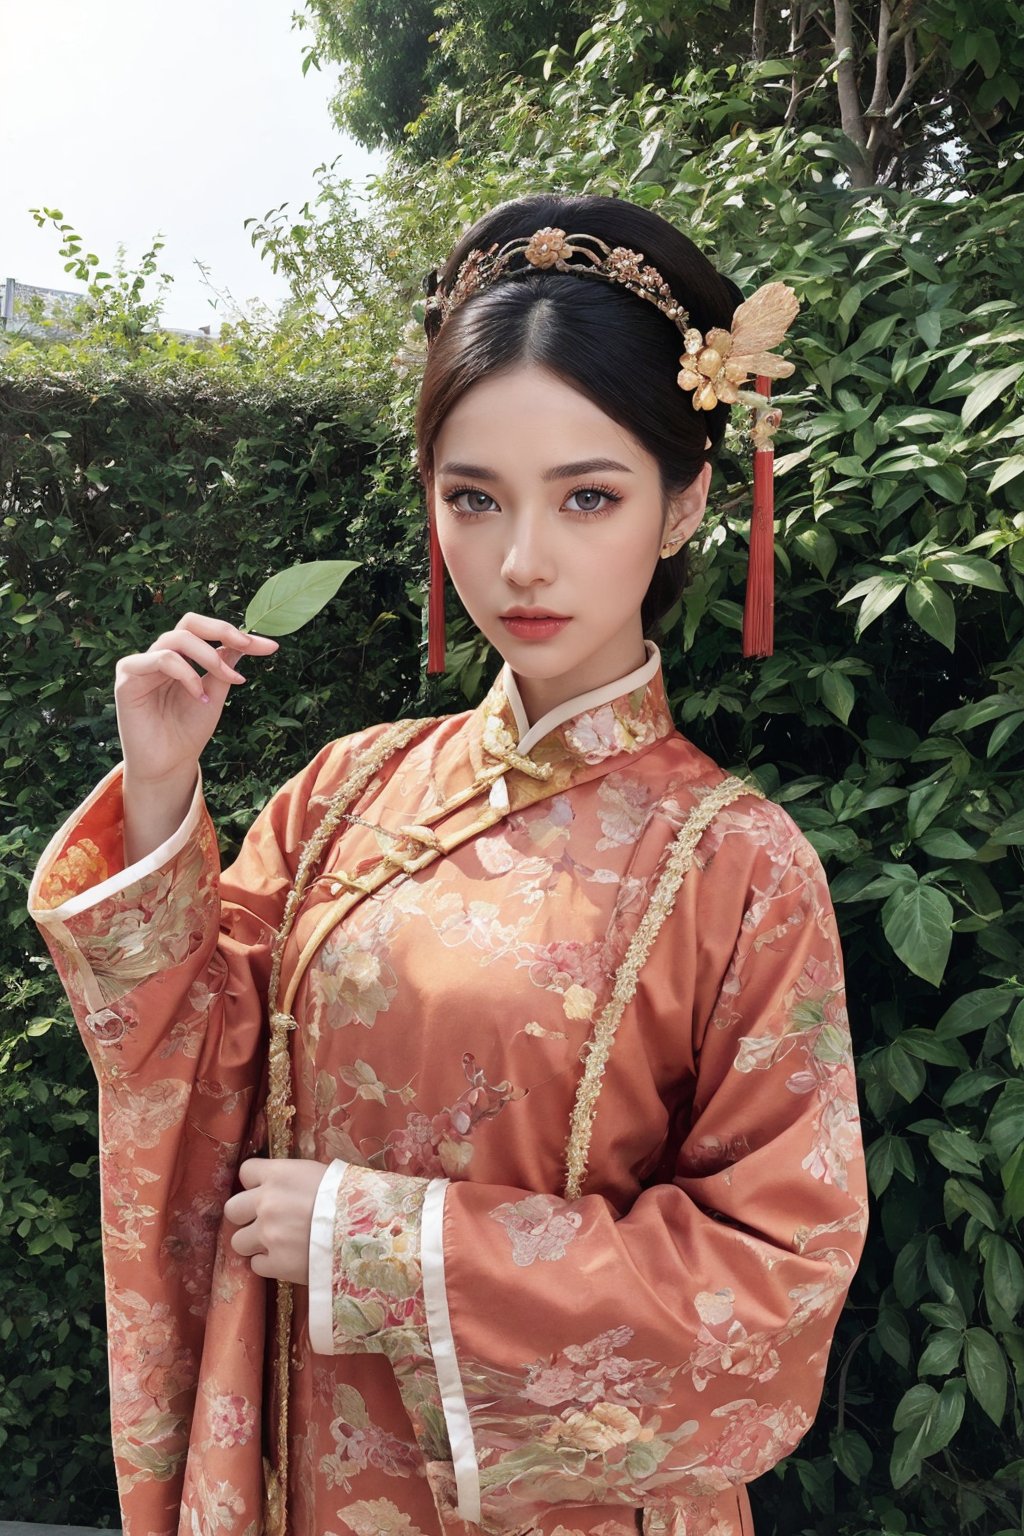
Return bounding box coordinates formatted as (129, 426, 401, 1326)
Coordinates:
(565, 777, 765, 1200)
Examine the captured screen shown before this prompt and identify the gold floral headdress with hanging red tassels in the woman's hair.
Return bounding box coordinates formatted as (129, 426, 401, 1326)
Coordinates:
(424, 226, 800, 671)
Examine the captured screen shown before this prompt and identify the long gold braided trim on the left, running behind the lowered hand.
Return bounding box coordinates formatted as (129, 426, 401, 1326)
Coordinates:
(263, 719, 434, 1536)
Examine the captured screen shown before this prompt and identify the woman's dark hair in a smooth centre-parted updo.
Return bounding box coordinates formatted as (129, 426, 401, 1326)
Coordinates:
(416, 194, 743, 634)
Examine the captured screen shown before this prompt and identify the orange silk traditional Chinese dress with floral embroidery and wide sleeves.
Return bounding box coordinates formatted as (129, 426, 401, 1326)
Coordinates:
(29, 644, 866, 1536)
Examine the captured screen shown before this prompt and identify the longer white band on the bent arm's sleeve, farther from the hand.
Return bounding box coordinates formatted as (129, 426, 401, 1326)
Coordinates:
(421, 1178, 481, 1525)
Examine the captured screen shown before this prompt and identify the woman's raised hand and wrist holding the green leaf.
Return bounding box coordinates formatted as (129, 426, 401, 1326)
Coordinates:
(114, 613, 278, 863)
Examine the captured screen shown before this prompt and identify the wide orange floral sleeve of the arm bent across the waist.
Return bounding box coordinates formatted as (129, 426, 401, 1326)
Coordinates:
(314, 806, 866, 1533)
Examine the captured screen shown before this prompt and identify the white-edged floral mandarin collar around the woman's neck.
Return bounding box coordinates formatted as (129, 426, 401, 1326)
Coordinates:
(471, 641, 676, 780)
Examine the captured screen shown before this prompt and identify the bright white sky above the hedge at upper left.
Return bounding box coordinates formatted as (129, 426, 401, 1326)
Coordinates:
(0, 0, 384, 333)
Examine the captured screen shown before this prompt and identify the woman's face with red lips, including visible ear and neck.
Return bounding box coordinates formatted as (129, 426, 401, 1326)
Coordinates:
(430, 364, 711, 720)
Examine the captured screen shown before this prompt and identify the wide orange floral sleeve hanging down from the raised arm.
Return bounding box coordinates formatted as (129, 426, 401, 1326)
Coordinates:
(29, 737, 388, 1511)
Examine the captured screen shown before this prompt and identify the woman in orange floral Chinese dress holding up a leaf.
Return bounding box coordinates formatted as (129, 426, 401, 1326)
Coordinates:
(31, 197, 866, 1536)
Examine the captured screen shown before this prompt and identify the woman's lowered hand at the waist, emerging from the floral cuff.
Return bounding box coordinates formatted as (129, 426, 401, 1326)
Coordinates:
(224, 1158, 327, 1286)
